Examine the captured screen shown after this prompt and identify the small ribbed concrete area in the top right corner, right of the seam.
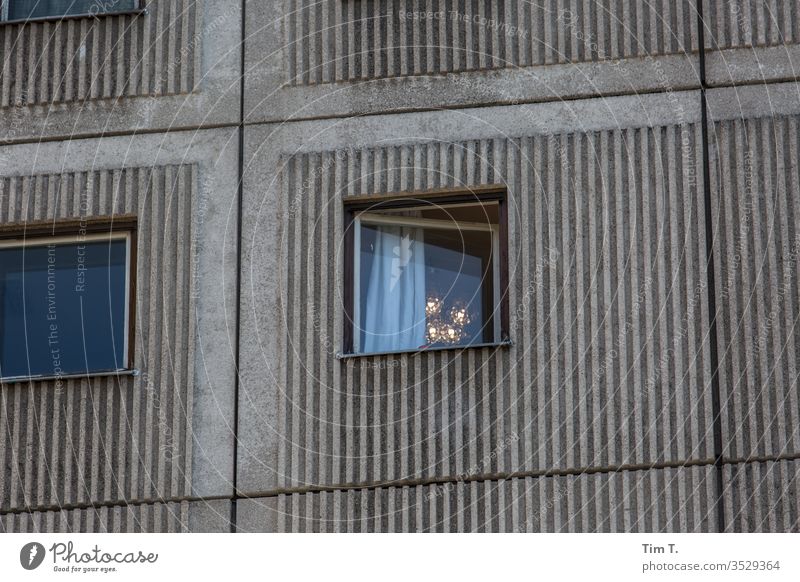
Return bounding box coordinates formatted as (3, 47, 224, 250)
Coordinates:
(704, 0, 800, 49)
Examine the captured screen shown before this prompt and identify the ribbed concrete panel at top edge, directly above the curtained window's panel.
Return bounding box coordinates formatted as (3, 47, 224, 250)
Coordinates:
(284, 0, 697, 85)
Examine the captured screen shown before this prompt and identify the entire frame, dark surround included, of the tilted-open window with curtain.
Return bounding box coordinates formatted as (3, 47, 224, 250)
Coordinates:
(337, 186, 510, 358)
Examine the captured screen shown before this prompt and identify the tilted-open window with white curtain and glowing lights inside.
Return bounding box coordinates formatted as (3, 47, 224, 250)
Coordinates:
(345, 192, 507, 354)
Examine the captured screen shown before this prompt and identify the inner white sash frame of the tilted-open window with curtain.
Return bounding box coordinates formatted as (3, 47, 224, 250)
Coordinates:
(352, 210, 501, 356)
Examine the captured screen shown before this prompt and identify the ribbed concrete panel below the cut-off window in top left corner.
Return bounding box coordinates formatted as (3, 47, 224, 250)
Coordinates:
(0, 0, 201, 107)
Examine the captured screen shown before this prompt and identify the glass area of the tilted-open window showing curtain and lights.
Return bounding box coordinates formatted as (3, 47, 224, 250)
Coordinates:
(356, 204, 497, 353)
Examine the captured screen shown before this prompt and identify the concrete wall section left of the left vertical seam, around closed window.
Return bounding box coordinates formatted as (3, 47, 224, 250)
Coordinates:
(0, 0, 242, 531)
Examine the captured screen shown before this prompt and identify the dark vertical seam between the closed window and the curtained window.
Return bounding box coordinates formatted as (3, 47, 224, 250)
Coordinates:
(231, 0, 247, 533)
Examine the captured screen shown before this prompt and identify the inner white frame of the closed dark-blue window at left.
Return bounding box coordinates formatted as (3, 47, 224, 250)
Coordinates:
(0, 231, 135, 384)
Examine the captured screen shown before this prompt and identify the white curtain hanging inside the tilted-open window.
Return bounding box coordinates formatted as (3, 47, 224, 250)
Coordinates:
(361, 226, 425, 352)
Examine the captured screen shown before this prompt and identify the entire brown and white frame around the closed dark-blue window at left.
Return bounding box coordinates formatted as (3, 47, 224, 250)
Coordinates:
(0, 215, 138, 384)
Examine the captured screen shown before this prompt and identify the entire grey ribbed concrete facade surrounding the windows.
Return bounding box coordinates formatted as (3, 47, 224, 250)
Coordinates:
(0, 0, 800, 532)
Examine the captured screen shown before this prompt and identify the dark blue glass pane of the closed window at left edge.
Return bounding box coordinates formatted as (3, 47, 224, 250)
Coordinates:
(0, 240, 127, 377)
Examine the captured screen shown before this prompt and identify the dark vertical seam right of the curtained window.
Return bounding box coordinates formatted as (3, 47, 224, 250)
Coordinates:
(697, 0, 725, 533)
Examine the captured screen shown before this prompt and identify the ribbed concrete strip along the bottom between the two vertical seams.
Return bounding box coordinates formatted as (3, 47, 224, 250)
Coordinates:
(239, 466, 717, 532)
